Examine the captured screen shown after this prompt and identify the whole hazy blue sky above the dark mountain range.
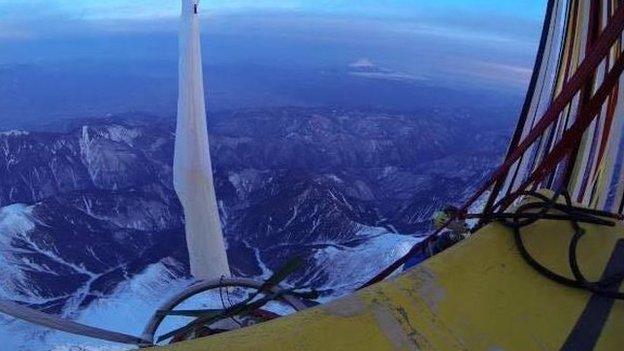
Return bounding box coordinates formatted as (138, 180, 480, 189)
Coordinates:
(0, 0, 545, 127)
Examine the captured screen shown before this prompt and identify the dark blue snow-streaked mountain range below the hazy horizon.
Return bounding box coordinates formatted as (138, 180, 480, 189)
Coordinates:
(0, 108, 505, 350)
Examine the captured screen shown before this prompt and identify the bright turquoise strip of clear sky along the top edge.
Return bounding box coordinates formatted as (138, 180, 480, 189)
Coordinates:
(0, 0, 544, 19)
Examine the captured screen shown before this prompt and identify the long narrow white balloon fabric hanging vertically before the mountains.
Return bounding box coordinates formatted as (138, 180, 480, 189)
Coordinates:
(173, 0, 230, 280)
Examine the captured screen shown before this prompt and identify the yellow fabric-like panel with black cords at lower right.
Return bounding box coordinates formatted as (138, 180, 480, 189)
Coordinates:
(149, 204, 624, 351)
